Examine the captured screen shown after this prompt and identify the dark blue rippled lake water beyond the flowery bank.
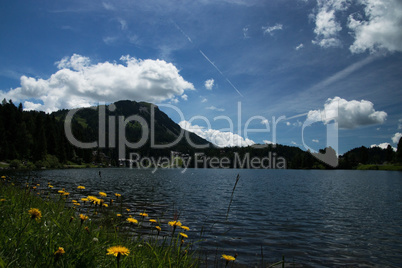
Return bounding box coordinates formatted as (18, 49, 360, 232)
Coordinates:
(14, 169, 402, 267)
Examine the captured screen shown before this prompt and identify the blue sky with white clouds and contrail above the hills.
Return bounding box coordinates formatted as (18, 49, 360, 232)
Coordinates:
(0, 0, 402, 154)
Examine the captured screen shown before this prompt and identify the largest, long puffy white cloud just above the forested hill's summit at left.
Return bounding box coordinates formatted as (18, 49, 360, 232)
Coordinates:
(0, 54, 194, 112)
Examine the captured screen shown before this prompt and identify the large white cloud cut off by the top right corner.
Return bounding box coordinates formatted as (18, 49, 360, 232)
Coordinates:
(348, 0, 402, 53)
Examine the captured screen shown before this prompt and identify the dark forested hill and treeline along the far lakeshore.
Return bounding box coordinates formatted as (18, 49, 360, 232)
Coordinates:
(0, 100, 402, 169)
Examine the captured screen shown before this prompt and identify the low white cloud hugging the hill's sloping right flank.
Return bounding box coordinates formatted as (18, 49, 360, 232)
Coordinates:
(179, 121, 255, 147)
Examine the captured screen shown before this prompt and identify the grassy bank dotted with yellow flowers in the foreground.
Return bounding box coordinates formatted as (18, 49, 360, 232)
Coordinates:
(0, 176, 198, 267)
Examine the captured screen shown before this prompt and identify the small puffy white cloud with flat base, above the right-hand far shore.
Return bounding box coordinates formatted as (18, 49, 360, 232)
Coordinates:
(307, 97, 387, 129)
